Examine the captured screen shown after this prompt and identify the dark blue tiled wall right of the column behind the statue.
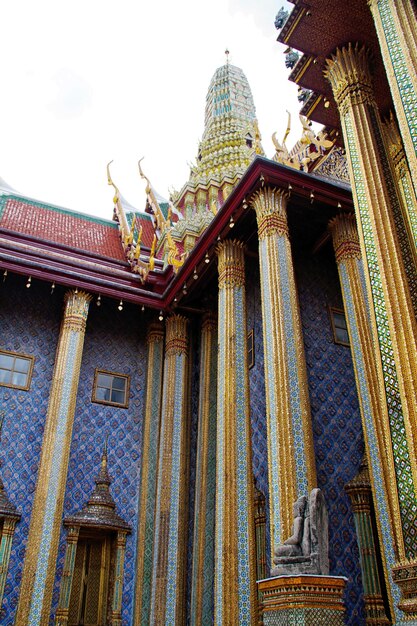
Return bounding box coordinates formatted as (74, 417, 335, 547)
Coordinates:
(296, 251, 365, 626)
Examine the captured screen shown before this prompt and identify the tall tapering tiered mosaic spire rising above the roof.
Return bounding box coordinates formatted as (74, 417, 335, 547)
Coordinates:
(170, 56, 264, 256)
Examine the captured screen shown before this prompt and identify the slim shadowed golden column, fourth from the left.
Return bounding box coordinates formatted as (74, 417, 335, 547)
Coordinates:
(190, 312, 217, 626)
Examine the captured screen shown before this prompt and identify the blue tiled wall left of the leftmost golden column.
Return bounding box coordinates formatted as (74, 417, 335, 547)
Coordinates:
(0, 275, 63, 626)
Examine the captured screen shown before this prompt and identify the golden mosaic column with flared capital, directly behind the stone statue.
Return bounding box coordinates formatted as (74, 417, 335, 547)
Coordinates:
(251, 187, 316, 555)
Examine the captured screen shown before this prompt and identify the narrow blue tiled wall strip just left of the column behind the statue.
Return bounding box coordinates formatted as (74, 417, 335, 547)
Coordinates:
(246, 257, 270, 568)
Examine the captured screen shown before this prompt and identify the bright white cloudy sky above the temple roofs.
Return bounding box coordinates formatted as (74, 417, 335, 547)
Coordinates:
(0, 0, 301, 219)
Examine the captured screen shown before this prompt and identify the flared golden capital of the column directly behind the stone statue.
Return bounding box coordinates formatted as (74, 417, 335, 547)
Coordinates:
(251, 187, 288, 239)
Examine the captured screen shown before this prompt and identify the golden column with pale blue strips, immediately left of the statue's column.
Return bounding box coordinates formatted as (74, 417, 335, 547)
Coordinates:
(214, 240, 257, 626)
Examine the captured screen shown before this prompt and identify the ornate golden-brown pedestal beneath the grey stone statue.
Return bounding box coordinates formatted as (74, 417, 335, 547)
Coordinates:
(258, 575, 346, 626)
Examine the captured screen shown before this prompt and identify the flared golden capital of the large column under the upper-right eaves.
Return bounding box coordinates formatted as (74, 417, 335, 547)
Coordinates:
(324, 43, 374, 114)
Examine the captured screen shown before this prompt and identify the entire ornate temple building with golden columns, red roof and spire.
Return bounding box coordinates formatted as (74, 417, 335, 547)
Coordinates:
(0, 0, 417, 626)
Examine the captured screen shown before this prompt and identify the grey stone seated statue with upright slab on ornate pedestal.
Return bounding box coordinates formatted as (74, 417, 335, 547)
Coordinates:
(271, 489, 329, 576)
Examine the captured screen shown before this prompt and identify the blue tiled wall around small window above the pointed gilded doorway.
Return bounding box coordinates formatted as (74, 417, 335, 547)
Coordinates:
(52, 301, 147, 626)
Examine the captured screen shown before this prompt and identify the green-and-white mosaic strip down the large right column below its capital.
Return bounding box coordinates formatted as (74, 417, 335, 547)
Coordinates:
(343, 108, 417, 558)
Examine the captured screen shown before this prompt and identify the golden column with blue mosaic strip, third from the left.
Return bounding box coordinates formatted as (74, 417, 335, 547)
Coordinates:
(149, 315, 189, 626)
